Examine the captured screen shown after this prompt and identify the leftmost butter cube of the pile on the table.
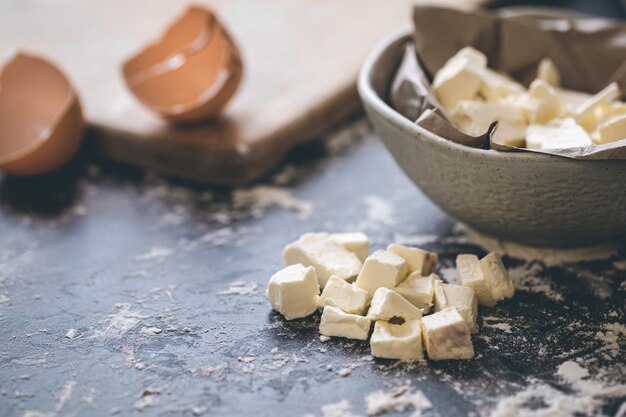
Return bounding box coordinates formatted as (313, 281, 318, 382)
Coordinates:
(266, 264, 320, 320)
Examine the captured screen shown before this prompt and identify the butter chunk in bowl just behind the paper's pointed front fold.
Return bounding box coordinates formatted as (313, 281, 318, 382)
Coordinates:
(452, 100, 526, 146)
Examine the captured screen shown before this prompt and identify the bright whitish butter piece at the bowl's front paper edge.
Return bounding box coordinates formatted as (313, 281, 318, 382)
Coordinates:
(526, 117, 592, 149)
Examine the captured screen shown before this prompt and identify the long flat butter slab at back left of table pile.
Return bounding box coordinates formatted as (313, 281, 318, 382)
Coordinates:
(283, 233, 363, 288)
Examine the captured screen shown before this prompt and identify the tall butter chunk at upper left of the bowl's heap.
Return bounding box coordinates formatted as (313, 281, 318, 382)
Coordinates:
(432, 47, 487, 109)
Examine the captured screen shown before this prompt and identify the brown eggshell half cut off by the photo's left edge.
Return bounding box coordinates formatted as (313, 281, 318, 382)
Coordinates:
(0, 53, 85, 175)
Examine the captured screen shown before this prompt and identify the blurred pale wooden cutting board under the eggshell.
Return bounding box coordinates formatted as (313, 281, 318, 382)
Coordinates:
(0, 0, 480, 186)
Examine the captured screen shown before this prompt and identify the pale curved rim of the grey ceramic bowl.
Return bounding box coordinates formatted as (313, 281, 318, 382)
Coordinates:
(357, 27, 572, 164)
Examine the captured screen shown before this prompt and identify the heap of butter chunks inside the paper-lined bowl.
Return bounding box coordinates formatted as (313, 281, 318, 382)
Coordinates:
(432, 47, 626, 149)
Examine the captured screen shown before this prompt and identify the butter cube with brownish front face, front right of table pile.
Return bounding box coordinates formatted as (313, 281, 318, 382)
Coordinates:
(422, 308, 474, 360)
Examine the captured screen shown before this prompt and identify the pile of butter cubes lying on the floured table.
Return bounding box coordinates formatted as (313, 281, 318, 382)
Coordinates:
(266, 233, 515, 360)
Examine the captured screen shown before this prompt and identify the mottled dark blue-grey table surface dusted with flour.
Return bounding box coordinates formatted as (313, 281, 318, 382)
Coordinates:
(0, 116, 626, 417)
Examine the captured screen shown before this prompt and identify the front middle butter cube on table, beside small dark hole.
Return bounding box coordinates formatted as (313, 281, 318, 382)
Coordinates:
(370, 320, 424, 360)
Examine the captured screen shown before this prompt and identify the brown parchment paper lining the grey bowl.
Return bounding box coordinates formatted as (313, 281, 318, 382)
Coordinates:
(390, 5, 626, 160)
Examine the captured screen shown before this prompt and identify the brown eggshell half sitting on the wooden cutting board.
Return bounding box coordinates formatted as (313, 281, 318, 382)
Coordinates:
(122, 6, 243, 123)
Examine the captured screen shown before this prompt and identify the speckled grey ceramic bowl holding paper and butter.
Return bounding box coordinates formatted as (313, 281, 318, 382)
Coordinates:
(358, 30, 626, 246)
